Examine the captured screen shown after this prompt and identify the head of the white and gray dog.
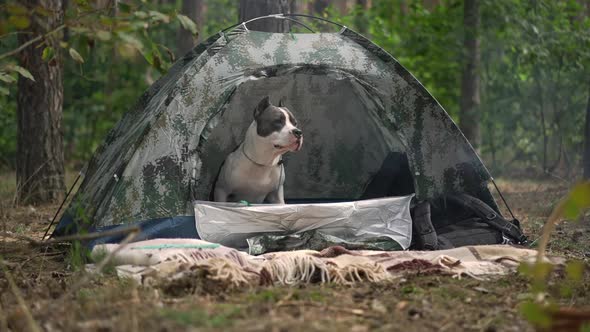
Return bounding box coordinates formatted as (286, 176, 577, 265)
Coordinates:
(254, 96, 303, 153)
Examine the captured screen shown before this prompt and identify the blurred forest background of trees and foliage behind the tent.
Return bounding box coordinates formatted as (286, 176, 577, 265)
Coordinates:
(0, 0, 590, 202)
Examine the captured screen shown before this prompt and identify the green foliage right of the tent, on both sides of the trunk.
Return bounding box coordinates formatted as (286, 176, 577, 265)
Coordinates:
(328, 0, 590, 175)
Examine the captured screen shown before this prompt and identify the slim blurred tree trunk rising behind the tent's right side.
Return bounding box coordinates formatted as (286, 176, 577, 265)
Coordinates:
(460, 0, 481, 149)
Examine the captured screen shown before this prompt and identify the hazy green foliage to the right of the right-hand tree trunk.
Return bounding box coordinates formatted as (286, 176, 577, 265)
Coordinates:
(482, 0, 590, 170)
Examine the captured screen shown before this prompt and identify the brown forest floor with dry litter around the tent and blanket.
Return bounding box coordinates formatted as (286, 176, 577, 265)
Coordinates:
(0, 174, 590, 332)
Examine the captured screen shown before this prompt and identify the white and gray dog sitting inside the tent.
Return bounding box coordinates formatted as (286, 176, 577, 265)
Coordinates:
(213, 96, 303, 204)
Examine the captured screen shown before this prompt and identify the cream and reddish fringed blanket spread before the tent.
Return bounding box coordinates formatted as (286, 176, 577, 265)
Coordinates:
(89, 239, 563, 287)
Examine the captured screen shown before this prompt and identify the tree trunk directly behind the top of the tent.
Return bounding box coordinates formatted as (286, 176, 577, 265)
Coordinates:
(239, 0, 295, 32)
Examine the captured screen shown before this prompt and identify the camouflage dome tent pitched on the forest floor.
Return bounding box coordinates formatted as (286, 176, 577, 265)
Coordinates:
(53, 15, 512, 242)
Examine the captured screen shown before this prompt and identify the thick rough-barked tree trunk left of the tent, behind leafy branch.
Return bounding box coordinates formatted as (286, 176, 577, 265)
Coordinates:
(16, 0, 65, 204)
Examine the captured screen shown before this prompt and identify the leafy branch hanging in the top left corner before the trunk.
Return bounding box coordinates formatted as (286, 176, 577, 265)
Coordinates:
(0, 0, 198, 94)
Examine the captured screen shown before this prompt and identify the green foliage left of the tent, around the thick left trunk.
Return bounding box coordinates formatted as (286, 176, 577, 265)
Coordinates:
(0, 0, 204, 168)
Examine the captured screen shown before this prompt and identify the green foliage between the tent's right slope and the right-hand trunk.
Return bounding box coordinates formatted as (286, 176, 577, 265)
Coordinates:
(328, 0, 463, 115)
